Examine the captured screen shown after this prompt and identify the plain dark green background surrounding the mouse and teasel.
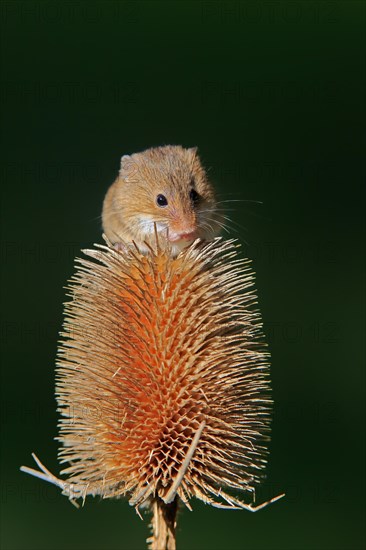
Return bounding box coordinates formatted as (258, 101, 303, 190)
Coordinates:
(1, 0, 365, 550)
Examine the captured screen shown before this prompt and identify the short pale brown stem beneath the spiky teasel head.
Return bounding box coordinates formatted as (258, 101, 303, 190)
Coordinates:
(147, 497, 178, 550)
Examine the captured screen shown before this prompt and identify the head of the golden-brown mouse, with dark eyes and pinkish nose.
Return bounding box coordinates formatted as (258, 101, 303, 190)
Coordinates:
(120, 145, 219, 253)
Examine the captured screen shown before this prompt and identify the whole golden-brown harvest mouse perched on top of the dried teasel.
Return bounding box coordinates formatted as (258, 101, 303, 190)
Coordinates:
(102, 145, 223, 256)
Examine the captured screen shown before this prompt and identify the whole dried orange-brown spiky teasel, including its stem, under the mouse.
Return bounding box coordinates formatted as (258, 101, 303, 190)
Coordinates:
(22, 238, 282, 550)
